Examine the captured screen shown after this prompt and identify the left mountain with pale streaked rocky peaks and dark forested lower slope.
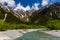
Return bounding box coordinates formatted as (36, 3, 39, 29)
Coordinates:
(0, 4, 31, 23)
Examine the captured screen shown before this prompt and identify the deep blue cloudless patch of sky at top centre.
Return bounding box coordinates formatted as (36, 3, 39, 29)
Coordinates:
(14, 0, 42, 7)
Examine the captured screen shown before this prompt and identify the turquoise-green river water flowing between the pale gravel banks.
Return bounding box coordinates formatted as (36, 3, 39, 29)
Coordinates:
(16, 31, 60, 40)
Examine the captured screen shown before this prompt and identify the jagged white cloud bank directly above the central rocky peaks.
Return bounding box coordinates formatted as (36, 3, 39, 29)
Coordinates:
(14, 3, 39, 11)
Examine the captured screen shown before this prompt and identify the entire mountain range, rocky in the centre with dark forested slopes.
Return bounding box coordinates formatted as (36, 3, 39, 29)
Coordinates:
(0, 2, 60, 24)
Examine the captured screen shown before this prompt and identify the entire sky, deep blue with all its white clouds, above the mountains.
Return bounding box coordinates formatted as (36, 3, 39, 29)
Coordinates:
(0, 0, 60, 11)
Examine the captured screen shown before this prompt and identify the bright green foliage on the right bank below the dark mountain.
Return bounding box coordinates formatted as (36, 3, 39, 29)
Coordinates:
(47, 20, 60, 30)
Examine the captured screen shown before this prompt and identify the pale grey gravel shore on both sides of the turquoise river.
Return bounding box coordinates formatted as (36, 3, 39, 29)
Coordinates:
(0, 29, 60, 40)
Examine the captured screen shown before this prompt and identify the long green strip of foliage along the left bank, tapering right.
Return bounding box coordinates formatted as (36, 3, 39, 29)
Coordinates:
(0, 20, 45, 31)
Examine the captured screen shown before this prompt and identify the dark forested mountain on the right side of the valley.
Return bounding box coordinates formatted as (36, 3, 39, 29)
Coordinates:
(31, 3, 60, 24)
